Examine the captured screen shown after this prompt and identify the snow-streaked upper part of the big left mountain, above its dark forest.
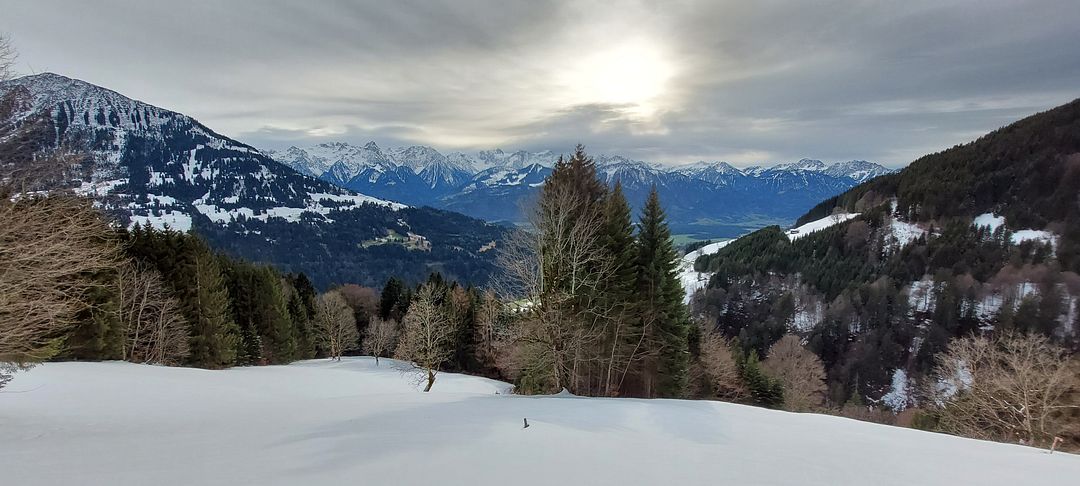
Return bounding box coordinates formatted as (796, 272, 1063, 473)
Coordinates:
(0, 72, 405, 231)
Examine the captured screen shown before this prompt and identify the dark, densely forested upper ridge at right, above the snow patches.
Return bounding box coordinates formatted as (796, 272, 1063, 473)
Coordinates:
(798, 99, 1080, 271)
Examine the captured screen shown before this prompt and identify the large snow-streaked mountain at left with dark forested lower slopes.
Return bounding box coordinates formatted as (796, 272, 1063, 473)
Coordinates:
(0, 73, 505, 287)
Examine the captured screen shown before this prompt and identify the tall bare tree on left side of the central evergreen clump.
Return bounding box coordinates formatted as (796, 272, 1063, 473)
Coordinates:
(499, 184, 629, 391)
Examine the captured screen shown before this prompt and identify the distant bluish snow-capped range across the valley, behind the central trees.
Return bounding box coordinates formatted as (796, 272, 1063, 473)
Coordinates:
(264, 141, 892, 238)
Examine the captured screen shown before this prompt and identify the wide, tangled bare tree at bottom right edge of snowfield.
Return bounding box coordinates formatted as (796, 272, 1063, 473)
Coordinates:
(928, 333, 1080, 446)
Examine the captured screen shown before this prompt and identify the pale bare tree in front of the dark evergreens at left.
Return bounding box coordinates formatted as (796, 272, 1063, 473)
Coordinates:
(116, 264, 191, 365)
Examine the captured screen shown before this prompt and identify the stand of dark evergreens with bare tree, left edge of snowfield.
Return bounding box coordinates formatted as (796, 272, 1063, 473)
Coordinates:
(59, 226, 318, 369)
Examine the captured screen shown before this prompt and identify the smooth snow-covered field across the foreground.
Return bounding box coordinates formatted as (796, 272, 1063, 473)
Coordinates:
(0, 357, 1080, 485)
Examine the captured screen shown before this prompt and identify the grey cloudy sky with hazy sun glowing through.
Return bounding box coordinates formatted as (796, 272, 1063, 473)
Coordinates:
(0, 0, 1080, 167)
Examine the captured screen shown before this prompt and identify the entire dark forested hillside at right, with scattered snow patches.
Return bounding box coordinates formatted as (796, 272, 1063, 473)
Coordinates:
(694, 100, 1080, 410)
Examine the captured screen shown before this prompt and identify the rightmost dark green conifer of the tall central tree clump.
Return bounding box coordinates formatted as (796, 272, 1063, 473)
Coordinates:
(636, 187, 690, 396)
